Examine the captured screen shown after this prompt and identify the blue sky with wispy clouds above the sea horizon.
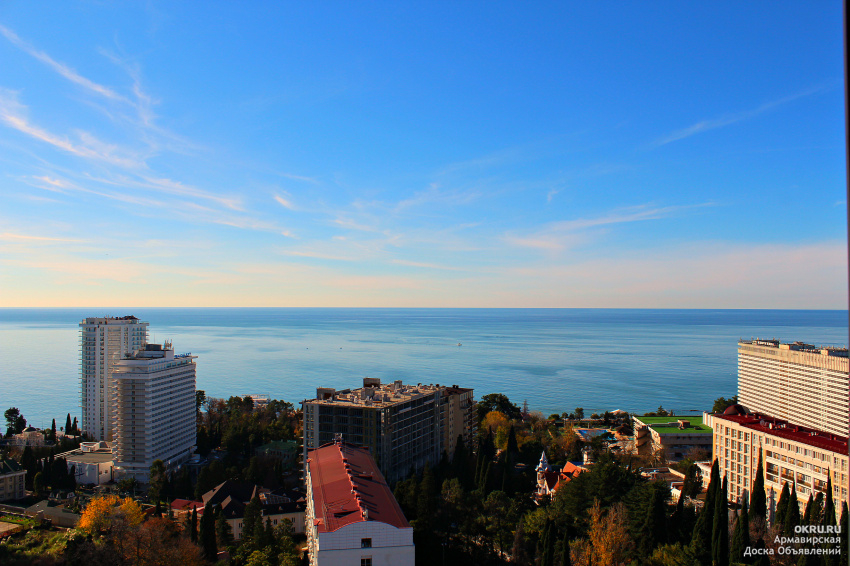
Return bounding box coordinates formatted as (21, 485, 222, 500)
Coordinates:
(0, 1, 847, 309)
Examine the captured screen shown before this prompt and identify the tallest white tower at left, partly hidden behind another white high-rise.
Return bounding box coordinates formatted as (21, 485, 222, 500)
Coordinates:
(80, 316, 148, 440)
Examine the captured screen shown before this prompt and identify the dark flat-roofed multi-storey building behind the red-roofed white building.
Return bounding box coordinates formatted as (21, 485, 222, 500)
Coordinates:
(302, 377, 474, 482)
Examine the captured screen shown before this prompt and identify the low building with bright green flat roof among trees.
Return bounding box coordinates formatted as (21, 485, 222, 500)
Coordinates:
(632, 415, 711, 462)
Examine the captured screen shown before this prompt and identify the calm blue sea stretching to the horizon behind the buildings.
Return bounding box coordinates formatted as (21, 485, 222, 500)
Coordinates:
(0, 308, 848, 426)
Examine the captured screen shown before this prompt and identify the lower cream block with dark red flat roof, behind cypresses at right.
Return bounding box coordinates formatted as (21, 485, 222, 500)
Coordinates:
(703, 405, 850, 519)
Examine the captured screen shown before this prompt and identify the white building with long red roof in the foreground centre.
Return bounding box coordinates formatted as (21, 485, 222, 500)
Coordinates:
(305, 441, 415, 566)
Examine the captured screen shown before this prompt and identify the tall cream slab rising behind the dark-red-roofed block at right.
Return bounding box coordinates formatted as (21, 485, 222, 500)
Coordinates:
(738, 340, 850, 437)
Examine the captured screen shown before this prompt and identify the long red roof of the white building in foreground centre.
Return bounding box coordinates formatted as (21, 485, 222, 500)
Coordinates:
(307, 442, 410, 533)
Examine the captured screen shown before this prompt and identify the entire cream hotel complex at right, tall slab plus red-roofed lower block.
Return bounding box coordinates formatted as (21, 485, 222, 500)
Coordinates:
(703, 340, 850, 520)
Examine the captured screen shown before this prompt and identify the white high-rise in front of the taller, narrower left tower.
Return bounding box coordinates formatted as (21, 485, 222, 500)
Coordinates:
(112, 342, 197, 482)
